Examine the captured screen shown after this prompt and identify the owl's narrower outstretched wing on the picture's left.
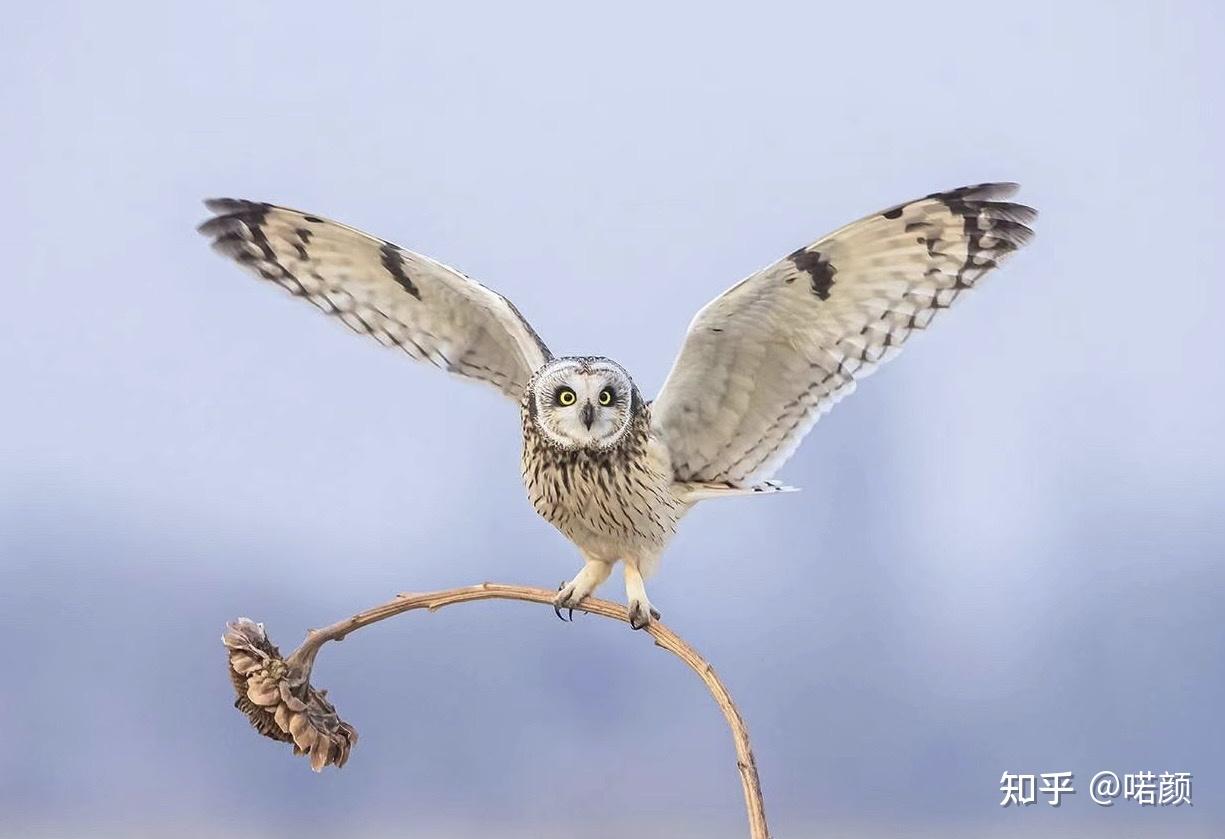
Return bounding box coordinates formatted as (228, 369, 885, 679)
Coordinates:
(200, 198, 551, 401)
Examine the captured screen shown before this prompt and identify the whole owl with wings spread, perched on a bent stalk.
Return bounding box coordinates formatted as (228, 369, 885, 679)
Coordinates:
(200, 184, 1036, 630)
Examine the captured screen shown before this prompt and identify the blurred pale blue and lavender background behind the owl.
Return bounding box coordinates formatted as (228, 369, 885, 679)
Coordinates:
(0, 0, 1225, 839)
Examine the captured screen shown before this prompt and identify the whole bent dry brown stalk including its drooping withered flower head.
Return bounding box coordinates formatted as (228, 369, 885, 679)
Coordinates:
(222, 583, 769, 839)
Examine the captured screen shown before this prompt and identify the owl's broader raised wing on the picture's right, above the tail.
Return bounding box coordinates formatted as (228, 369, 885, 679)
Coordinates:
(652, 184, 1036, 486)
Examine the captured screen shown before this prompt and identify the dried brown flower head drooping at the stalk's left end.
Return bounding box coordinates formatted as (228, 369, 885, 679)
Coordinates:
(222, 617, 358, 772)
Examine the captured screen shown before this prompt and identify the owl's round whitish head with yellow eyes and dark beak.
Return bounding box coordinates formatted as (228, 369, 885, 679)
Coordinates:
(527, 358, 642, 448)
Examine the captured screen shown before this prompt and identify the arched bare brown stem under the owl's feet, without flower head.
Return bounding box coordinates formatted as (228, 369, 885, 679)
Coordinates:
(285, 583, 769, 839)
